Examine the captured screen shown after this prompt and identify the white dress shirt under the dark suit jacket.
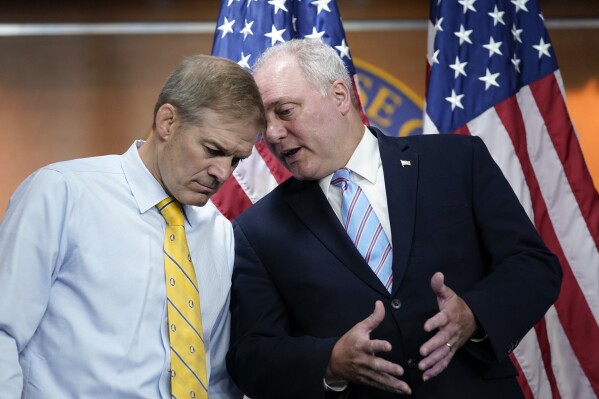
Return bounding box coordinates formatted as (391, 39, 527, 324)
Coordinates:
(318, 127, 392, 243)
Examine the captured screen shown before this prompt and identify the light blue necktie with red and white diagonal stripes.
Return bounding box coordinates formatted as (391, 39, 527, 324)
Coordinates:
(331, 168, 393, 292)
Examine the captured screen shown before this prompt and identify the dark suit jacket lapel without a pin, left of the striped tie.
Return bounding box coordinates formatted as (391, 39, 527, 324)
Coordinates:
(287, 181, 389, 295)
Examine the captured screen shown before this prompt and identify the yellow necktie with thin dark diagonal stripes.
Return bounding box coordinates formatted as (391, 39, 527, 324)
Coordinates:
(156, 197, 208, 399)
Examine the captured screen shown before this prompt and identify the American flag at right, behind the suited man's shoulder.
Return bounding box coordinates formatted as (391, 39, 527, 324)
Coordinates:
(424, 0, 599, 399)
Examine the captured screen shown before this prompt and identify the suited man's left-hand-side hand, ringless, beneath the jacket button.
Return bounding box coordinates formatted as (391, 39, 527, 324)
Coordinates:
(326, 301, 412, 394)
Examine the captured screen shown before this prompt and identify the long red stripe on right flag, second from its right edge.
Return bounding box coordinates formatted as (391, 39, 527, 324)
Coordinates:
(495, 97, 599, 392)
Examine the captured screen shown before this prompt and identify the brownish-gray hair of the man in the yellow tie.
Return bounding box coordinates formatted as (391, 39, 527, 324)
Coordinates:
(152, 55, 266, 134)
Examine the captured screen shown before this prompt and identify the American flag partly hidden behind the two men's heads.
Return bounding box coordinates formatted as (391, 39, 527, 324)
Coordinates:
(212, 0, 366, 219)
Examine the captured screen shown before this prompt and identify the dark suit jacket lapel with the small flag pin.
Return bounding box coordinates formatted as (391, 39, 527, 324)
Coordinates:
(377, 132, 418, 294)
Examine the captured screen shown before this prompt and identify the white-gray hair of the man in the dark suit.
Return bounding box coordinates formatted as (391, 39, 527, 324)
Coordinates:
(252, 39, 357, 107)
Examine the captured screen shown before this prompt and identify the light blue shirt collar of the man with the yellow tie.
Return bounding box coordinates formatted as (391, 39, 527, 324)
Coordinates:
(122, 140, 168, 213)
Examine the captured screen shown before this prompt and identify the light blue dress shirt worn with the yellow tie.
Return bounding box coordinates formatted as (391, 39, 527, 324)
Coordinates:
(0, 141, 242, 399)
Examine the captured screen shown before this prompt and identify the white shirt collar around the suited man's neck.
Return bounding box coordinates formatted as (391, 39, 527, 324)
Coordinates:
(318, 126, 381, 193)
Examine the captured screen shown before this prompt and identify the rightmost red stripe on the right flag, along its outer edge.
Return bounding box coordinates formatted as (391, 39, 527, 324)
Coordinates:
(530, 74, 599, 248)
